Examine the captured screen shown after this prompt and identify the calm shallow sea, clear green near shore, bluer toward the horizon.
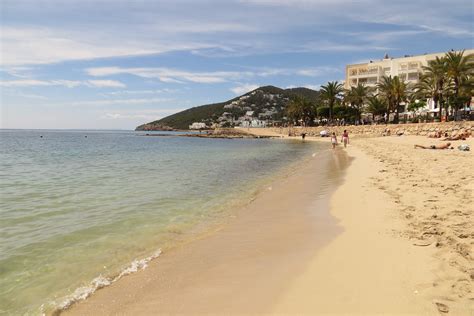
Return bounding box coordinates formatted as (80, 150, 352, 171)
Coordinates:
(0, 130, 317, 314)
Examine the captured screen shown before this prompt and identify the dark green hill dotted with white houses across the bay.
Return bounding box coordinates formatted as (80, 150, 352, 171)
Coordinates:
(136, 86, 319, 130)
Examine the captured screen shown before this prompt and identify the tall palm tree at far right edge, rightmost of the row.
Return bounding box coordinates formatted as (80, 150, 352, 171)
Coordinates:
(445, 50, 474, 117)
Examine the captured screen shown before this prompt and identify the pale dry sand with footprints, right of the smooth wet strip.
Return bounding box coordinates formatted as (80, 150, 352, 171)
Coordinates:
(274, 137, 474, 315)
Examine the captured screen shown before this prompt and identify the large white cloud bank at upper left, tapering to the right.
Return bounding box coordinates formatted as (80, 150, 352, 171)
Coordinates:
(0, 27, 213, 66)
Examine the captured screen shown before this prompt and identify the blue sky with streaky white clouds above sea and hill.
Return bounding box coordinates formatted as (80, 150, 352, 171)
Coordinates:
(0, 0, 474, 129)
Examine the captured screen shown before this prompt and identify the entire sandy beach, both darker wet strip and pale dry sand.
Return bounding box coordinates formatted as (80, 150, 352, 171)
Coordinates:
(65, 129, 474, 315)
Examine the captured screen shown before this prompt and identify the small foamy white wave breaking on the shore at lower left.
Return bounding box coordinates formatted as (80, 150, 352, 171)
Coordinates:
(41, 249, 162, 315)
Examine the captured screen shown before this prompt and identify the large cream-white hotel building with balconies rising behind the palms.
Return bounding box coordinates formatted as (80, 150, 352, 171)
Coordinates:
(344, 49, 474, 113)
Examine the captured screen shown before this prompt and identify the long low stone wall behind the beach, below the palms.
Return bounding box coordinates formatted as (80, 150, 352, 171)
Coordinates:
(271, 121, 474, 136)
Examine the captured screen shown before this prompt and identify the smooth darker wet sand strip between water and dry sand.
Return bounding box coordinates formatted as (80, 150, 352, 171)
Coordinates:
(64, 150, 350, 315)
